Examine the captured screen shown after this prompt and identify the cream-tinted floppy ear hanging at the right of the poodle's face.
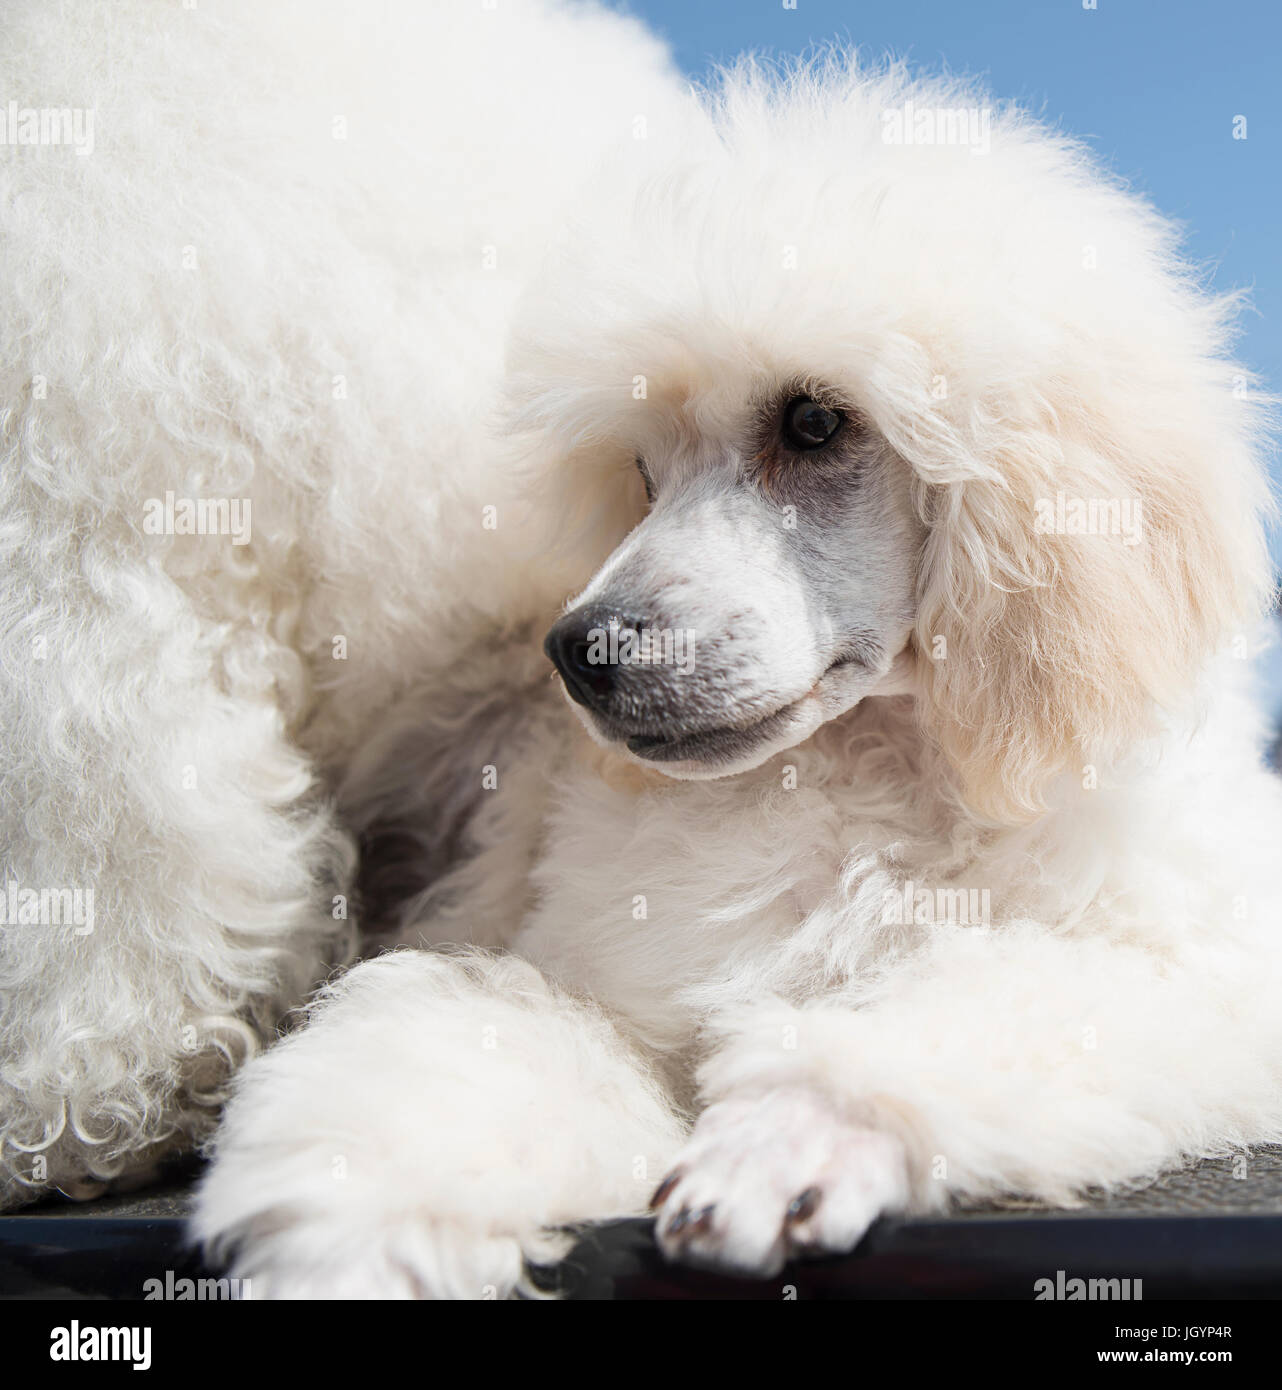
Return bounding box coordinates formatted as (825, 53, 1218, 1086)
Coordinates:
(916, 361, 1271, 823)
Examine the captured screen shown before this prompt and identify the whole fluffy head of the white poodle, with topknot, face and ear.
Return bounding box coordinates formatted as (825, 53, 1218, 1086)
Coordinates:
(513, 63, 1268, 820)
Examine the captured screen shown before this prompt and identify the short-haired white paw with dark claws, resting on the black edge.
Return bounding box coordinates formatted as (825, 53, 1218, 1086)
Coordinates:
(651, 1090, 908, 1276)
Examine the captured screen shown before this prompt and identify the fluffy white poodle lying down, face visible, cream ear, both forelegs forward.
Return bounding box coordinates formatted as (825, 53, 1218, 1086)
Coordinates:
(196, 10, 1282, 1297)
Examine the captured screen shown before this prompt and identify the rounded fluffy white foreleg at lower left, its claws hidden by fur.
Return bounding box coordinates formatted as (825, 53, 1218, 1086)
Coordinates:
(195, 951, 681, 1298)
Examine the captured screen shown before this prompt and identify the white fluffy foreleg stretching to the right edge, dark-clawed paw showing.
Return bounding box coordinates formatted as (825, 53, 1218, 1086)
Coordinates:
(656, 929, 1282, 1273)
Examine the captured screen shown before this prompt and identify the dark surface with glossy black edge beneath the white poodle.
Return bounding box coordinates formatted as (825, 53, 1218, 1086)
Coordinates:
(0, 1148, 1282, 1301)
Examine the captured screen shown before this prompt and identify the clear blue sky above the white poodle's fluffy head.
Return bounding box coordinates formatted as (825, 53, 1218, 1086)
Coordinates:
(616, 0, 1282, 562)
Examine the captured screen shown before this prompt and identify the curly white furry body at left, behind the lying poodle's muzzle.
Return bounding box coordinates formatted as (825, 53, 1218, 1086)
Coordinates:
(0, 0, 677, 1202)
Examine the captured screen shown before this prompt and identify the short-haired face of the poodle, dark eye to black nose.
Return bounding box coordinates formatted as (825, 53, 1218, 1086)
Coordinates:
(533, 364, 925, 777)
